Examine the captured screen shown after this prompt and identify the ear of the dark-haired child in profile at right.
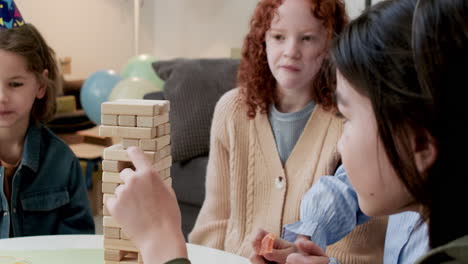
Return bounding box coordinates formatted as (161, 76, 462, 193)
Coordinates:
(413, 131, 437, 173)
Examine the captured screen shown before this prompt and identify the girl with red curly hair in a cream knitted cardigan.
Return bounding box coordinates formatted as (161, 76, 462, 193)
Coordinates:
(189, 0, 386, 264)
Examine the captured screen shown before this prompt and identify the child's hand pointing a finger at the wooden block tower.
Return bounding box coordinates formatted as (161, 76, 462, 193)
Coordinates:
(106, 147, 187, 263)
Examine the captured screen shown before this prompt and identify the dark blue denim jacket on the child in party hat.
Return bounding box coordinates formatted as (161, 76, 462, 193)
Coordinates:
(0, 122, 94, 238)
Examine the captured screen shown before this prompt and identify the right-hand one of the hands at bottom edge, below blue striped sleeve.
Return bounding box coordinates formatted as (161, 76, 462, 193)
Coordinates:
(286, 236, 330, 264)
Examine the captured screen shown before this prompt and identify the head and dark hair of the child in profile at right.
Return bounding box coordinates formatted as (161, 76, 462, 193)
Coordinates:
(333, 0, 468, 263)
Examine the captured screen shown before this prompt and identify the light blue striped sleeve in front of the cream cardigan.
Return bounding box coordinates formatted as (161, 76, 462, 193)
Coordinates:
(283, 166, 370, 249)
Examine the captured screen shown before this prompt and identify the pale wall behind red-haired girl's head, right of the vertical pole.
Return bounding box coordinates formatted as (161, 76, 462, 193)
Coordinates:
(153, 0, 365, 59)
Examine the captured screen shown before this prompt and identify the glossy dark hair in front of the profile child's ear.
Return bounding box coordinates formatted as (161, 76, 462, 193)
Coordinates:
(332, 0, 426, 226)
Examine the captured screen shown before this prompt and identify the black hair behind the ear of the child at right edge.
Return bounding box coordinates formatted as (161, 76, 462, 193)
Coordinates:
(413, 0, 468, 250)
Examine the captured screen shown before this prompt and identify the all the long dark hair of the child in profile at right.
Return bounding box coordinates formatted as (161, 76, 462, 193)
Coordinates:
(332, 0, 468, 248)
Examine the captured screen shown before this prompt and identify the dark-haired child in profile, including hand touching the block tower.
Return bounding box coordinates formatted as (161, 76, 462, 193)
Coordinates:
(107, 0, 468, 264)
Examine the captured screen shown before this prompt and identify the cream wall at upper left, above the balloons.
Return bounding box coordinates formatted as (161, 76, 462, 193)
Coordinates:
(15, 0, 154, 79)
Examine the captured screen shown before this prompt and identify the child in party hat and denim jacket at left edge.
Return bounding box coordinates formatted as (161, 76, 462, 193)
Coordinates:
(0, 1, 94, 238)
